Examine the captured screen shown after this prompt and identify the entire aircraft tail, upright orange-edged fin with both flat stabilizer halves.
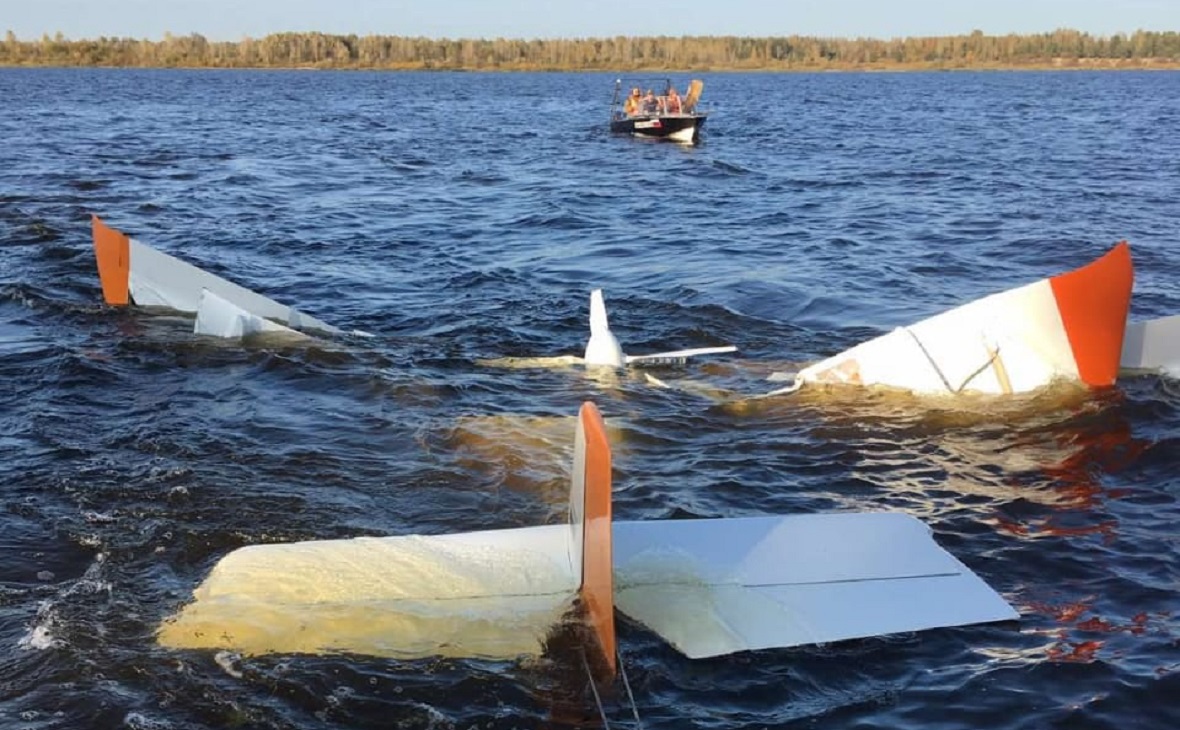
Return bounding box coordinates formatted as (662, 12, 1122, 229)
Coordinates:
(158, 402, 1018, 671)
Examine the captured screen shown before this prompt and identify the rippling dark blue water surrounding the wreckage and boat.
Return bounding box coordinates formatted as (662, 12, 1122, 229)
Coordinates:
(0, 70, 1180, 729)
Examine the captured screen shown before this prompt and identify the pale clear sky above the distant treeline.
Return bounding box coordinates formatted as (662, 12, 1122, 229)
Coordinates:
(0, 0, 1180, 41)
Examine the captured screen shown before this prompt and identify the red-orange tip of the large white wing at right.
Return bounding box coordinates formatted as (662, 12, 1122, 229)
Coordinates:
(1049, 241, 1135, 388)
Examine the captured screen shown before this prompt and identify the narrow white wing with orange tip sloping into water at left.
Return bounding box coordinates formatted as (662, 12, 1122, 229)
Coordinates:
(91, 216, 340, 336)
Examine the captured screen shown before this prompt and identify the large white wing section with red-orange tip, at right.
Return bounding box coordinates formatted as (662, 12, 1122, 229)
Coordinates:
(774, 242, 1134, 394)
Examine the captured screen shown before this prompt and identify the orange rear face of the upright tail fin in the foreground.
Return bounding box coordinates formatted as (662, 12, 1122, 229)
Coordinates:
(578, 401, 617, 676)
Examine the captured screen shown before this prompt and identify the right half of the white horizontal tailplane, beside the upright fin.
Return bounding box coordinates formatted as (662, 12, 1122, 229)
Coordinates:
(614, 513, 1017, 658)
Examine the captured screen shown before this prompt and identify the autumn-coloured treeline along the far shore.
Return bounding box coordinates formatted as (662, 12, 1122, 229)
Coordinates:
(0, 29, 1180, 71)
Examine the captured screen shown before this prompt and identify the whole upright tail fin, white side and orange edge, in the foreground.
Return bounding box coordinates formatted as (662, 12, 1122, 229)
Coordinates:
(570, 401, 616, 676)
